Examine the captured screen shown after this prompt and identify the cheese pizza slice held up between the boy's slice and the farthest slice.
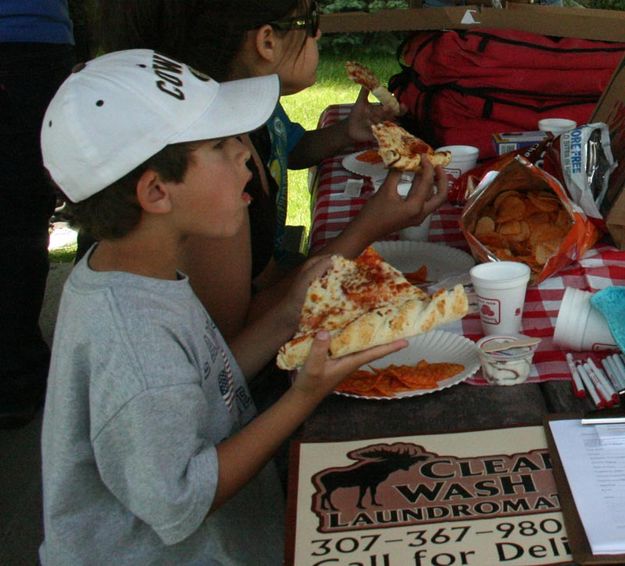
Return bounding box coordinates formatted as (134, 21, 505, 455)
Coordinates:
(371, 121, 451, 172)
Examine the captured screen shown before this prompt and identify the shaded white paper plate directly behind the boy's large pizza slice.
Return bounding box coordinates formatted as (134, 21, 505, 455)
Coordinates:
(373, 240, 475, 282)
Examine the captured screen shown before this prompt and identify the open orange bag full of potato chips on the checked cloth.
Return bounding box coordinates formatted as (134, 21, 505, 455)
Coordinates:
(460, 156, 600, 283)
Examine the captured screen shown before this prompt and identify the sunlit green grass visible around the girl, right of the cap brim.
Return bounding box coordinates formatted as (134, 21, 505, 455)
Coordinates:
(281, 52, 400, 240)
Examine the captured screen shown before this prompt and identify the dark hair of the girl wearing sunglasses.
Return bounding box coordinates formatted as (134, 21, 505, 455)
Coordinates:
(99, 0, 309, 81)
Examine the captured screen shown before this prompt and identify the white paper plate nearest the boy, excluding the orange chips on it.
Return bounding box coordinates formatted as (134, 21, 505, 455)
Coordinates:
(335, 330, 480, 401)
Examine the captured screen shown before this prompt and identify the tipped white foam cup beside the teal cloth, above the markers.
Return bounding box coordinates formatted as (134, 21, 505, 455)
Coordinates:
(553, 287, 618, 352)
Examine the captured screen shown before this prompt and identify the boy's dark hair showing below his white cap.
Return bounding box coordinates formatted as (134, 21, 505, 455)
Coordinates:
(64, 142, 197, 240)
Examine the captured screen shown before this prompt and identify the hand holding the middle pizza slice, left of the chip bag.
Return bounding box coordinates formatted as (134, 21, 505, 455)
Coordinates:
(357, 156, 447, 242)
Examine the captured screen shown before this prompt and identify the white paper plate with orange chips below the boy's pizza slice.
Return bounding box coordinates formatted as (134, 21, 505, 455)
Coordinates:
(335, 330, 480, 400)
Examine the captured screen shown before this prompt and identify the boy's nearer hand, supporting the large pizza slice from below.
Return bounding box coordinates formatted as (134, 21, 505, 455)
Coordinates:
(293, 336, 408, 401)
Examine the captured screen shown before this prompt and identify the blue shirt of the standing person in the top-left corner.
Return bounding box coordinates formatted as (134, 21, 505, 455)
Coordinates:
(0, 0, 74, 45)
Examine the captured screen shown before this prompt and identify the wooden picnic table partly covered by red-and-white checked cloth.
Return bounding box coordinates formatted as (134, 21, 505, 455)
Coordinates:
(298, 105, 625, 441)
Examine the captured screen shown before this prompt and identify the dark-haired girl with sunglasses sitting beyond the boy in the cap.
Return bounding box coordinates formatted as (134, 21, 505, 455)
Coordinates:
(100, 0, 446, 338)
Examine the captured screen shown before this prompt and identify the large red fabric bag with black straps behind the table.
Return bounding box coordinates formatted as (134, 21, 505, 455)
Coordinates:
(389, 28, 625, 159)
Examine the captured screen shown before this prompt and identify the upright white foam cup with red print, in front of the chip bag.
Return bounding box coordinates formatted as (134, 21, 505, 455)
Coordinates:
(469, 261, 530, 336)
